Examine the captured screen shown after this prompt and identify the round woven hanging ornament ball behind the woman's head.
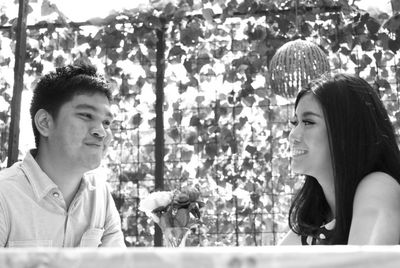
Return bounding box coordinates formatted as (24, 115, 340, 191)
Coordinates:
(269, 39, 330, 97)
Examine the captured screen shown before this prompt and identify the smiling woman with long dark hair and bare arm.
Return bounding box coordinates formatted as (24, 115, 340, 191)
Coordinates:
(280, 74, 400, 245)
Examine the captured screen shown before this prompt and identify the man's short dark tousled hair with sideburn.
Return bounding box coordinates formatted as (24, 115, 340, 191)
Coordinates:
(30, 65, 112, 148)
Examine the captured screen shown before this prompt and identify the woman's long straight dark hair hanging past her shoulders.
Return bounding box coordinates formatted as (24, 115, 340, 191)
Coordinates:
(289, 74, 400, 244)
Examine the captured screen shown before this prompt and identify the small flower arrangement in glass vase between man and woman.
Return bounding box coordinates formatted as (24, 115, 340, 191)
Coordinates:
(139, 187, 204, 246)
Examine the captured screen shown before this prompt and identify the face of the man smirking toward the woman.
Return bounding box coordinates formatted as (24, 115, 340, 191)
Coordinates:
(48, 93, 113, 172)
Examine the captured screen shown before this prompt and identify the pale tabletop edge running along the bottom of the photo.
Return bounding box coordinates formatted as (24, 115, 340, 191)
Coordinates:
(0, 246, 400, 268)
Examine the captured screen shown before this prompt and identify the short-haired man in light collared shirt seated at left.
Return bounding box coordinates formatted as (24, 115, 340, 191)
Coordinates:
(0, 63, 125, 247)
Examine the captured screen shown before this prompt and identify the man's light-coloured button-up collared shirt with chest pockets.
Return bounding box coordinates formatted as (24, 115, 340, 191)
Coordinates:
(0, 153, 125, 247)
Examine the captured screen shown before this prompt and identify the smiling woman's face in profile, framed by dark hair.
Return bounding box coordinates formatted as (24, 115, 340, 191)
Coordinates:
(289, 93, 333, 179)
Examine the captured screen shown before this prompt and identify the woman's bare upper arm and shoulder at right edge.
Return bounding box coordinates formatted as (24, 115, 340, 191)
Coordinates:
(348, 172, 400, 245)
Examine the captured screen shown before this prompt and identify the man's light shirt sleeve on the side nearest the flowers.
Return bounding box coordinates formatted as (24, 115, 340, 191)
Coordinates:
(101, 185, 126, 247)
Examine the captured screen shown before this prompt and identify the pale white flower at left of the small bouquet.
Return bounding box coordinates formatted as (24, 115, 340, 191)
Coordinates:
(139, 191, 174, 223)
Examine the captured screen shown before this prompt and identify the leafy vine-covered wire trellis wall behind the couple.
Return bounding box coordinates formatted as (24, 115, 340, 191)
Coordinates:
(0, 0, 400, 246)
